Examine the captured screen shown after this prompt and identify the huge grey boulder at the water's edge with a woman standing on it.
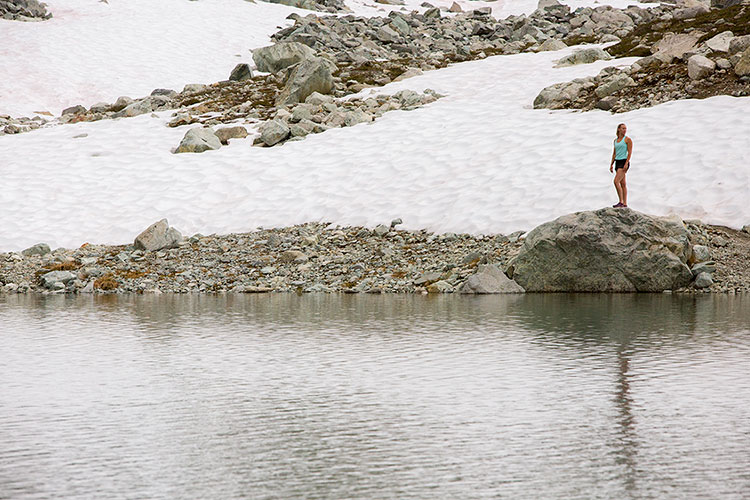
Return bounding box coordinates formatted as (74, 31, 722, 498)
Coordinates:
(507, 208, 692, 292)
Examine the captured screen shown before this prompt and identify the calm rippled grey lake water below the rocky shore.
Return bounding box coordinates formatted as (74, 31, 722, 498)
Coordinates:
(0, 295, 750, 499)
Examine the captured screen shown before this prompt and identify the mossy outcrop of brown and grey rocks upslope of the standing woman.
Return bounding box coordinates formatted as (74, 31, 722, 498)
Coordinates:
(534, 3, 750, 112)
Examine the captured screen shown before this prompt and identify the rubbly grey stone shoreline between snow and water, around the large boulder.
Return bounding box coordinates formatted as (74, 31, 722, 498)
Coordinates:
(0, 209, 750, 294)
